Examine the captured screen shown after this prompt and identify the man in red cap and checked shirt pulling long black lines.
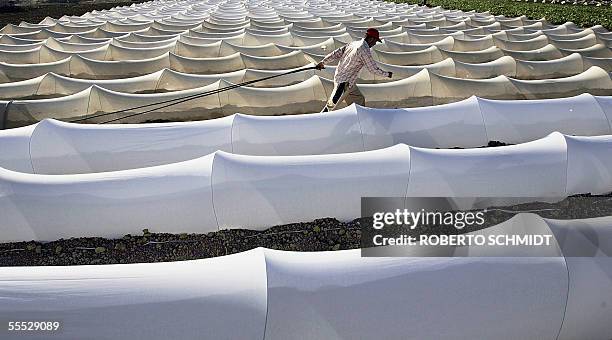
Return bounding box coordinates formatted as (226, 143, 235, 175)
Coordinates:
(316, 28, 393, 112)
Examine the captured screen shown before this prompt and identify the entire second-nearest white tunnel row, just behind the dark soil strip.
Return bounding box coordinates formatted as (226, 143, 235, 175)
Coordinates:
(0, 132, 612, 242)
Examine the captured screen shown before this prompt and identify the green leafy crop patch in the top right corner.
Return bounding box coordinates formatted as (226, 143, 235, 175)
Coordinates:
(389, 0, 612, 30)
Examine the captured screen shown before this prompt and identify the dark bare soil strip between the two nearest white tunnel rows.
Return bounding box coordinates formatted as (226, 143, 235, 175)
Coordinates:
(0, 194, 612, 266)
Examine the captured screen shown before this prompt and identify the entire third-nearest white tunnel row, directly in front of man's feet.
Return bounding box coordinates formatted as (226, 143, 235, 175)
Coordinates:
(0, 94, 612, 174)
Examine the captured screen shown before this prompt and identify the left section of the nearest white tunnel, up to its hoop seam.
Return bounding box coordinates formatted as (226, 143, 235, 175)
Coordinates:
(0, 250, 268, 339)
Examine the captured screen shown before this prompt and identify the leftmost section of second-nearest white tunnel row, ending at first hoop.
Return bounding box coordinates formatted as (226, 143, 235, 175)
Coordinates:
(0, 155, 217, 240)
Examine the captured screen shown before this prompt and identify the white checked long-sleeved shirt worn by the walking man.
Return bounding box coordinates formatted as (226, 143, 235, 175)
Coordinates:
(321, 39, 389, 86)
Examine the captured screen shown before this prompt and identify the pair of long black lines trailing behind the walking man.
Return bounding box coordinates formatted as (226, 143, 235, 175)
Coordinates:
(69, 66, 316, 124)
